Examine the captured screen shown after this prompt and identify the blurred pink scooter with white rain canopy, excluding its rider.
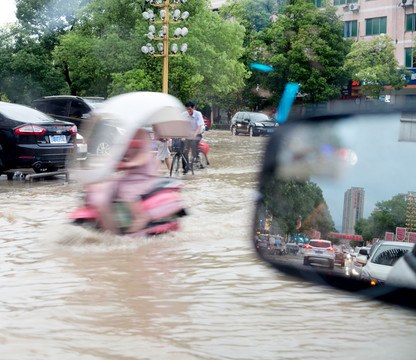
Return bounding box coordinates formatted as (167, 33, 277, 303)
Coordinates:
(67, 92, 190, 236)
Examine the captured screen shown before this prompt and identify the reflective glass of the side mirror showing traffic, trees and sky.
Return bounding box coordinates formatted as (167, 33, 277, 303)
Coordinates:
(254, 113, 416, 287)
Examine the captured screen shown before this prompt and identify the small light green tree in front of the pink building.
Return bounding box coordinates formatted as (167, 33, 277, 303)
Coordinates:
(344, 35, 411, 97)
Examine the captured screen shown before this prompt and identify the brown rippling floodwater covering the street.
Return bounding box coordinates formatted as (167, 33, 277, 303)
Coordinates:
(0, 131, 416, 360)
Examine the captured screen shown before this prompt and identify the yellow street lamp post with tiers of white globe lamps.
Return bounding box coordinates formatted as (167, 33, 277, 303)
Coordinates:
(142, 0, 189, 94)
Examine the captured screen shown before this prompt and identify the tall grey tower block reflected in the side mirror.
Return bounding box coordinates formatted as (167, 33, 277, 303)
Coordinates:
(342, 187, 365, 235)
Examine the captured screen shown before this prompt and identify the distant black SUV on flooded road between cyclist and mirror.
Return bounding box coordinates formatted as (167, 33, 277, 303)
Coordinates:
(230, 111, 278, 136)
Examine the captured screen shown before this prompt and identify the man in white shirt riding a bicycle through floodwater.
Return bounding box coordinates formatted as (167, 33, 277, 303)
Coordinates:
(182, 101, 204, 174)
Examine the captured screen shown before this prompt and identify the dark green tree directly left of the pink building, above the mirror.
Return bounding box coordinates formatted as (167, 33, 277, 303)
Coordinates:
(248, 0, 350, 102)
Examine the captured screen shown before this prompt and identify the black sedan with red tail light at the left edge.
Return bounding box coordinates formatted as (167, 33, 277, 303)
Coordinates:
(0, 102, 77, 179)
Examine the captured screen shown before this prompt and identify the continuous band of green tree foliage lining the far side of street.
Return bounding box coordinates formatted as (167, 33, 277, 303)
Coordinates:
(0, 0, 412, 110)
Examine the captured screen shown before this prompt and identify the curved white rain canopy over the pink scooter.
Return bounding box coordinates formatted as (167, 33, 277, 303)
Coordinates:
(70, 92, 191, 183)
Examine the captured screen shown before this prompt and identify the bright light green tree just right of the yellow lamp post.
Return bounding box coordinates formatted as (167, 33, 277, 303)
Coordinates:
(169, 5, 248, 106)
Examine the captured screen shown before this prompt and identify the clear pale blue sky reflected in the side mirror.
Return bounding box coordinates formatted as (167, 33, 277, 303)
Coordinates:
(313, 113, 416, 230)
